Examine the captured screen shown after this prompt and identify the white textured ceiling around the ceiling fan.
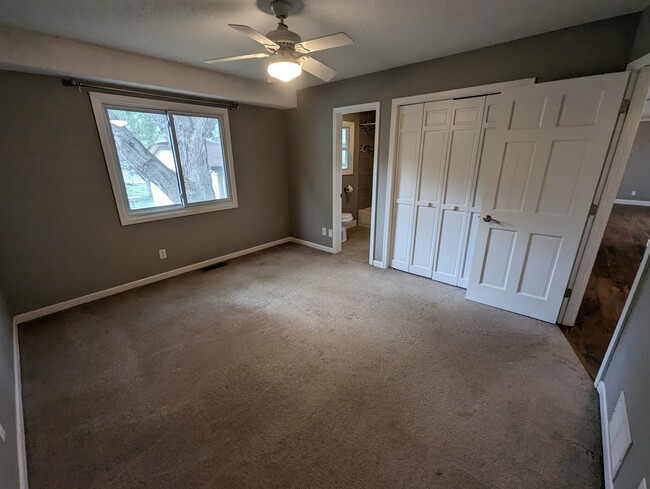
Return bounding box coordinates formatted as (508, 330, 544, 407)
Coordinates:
(0, 0, 650, 86)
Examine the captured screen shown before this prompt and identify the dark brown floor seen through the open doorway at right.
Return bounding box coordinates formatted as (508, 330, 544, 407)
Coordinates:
(562, 205, 650, 378)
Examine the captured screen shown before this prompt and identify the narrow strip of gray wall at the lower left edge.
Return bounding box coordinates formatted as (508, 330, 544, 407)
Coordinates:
(0, 292, 18, 489)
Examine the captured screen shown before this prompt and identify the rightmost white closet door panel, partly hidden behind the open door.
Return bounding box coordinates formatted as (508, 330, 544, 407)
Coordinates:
(458, 95, 505, 289)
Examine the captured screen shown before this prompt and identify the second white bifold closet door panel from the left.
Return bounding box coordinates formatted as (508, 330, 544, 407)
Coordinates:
(408, 100, 452, 277)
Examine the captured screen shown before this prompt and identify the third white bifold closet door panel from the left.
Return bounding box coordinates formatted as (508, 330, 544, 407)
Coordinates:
(431, 97, 485, 285)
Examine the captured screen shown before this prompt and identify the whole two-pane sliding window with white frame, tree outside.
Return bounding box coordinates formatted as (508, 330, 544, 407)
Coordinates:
(90, 93, 237, 225)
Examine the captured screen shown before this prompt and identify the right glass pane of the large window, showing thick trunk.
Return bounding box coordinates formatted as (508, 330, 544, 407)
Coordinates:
(173, 115, 229, 203)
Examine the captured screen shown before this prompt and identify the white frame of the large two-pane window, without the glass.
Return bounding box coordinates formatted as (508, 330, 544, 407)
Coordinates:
(90, 92, 238, 226)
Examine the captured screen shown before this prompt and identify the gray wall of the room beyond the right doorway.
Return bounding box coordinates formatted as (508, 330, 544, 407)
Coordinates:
(616, 122, 650, 201)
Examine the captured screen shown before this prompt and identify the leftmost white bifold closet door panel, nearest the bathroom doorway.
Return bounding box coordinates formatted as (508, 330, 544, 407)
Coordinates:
(391, 104, 423, 272)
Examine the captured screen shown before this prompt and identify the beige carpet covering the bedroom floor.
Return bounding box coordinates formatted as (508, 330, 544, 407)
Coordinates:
(20, 245, 602, 489)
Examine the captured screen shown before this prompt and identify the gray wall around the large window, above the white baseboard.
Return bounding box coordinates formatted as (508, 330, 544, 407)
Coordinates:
(0, 71, 288, 313)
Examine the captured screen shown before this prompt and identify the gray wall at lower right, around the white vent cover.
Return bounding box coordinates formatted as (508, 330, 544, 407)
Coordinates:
(603, 251, 650, 489)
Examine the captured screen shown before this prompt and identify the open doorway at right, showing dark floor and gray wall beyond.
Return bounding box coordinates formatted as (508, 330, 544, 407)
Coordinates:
(563, 119, 650, 378)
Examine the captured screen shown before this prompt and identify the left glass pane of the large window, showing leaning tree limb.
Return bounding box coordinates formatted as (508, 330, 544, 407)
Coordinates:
(107, 109, 181, 210)
